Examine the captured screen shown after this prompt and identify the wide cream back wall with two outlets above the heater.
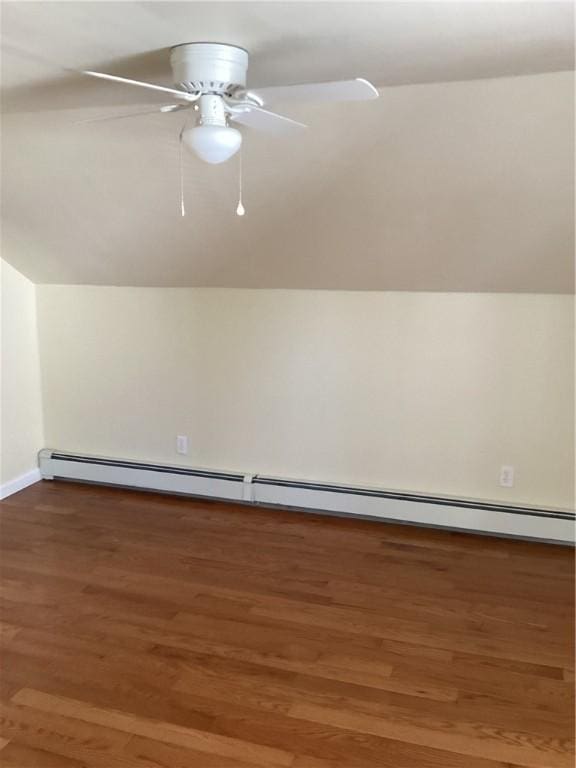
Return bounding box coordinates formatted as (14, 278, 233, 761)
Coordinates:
(38, 286, 574, 507)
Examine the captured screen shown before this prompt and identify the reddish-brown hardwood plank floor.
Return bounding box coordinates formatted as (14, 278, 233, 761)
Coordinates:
(0, 482, 574, 768)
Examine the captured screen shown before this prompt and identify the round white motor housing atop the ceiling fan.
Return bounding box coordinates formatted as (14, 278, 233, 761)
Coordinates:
(170, 43, 248, 95)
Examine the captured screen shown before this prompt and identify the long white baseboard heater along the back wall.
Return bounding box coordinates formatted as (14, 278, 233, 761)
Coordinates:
(39, 449, 576, 544)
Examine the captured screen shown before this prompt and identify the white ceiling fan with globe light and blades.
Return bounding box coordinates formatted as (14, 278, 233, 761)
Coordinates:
(82, 43, 379, 163)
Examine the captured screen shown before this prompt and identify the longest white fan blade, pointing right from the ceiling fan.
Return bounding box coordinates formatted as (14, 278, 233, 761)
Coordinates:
(247, 77, 380, 104)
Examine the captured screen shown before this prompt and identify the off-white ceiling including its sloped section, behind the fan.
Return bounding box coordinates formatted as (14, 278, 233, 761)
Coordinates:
(1, 2, 573, 292)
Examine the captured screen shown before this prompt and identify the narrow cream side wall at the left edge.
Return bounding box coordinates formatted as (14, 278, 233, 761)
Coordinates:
(0, 260, 44, 484)
